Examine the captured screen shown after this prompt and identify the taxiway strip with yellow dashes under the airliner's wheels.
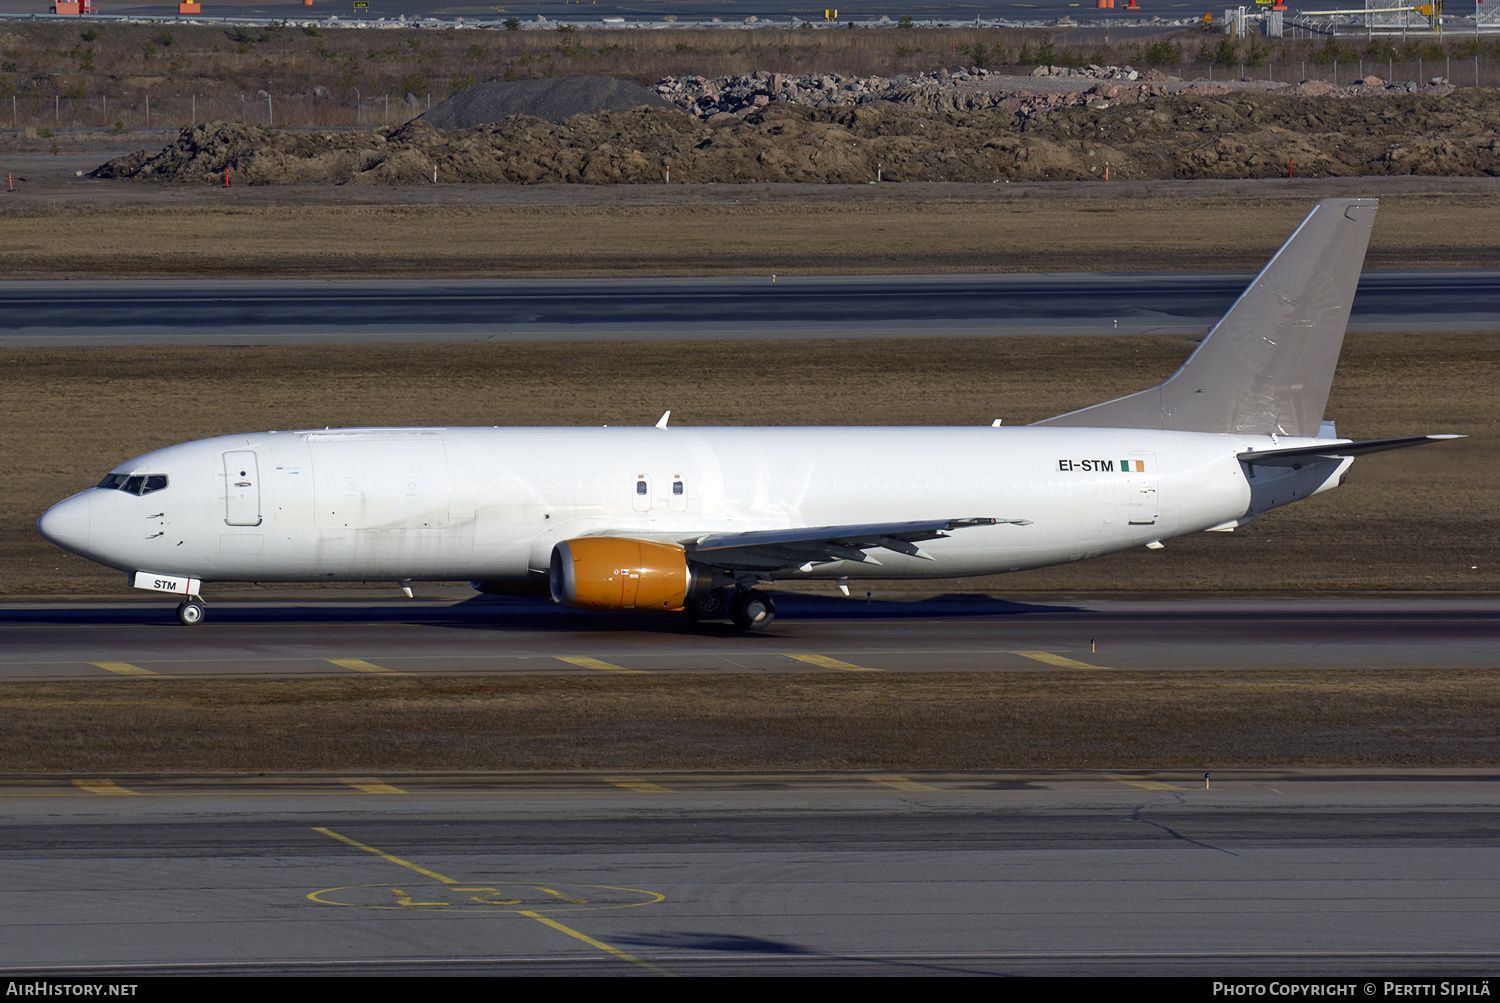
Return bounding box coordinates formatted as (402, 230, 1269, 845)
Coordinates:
(0, 586, 1500, 681)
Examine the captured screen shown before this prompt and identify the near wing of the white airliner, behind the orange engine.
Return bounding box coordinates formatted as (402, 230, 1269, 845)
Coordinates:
(681, 519, 1031, 571)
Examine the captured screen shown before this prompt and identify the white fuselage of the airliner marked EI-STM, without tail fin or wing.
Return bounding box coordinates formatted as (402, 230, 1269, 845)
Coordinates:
(42, 426, 1349, 592)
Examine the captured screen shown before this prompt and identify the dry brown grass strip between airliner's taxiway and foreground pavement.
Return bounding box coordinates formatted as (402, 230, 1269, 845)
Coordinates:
(0, 670, 1500, 775)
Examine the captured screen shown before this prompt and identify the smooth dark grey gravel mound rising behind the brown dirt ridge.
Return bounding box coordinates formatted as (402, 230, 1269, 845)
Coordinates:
(422, 76, 672, 129)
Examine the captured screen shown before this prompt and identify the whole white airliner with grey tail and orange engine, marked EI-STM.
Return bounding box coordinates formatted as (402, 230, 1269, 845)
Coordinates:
(39, 198, 1457, 628)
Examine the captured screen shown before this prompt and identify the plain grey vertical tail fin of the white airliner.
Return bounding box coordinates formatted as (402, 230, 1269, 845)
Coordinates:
(1035, 198, 1377, 436)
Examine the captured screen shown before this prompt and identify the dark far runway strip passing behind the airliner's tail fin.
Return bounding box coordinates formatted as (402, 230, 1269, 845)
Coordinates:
(0, 268, 1500, 348)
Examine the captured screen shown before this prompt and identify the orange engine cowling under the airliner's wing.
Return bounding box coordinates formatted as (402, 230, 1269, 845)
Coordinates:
(548, 537, 693, 610)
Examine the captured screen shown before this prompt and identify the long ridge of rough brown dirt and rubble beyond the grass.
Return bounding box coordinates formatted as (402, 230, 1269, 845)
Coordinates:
(95, 84, 1500, 184)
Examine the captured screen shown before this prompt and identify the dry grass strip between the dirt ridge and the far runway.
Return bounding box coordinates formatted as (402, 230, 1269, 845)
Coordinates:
(0, 189, 1500, 279)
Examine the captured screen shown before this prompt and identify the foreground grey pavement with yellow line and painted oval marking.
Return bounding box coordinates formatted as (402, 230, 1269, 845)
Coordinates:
(0, 772, 1500, 971)
